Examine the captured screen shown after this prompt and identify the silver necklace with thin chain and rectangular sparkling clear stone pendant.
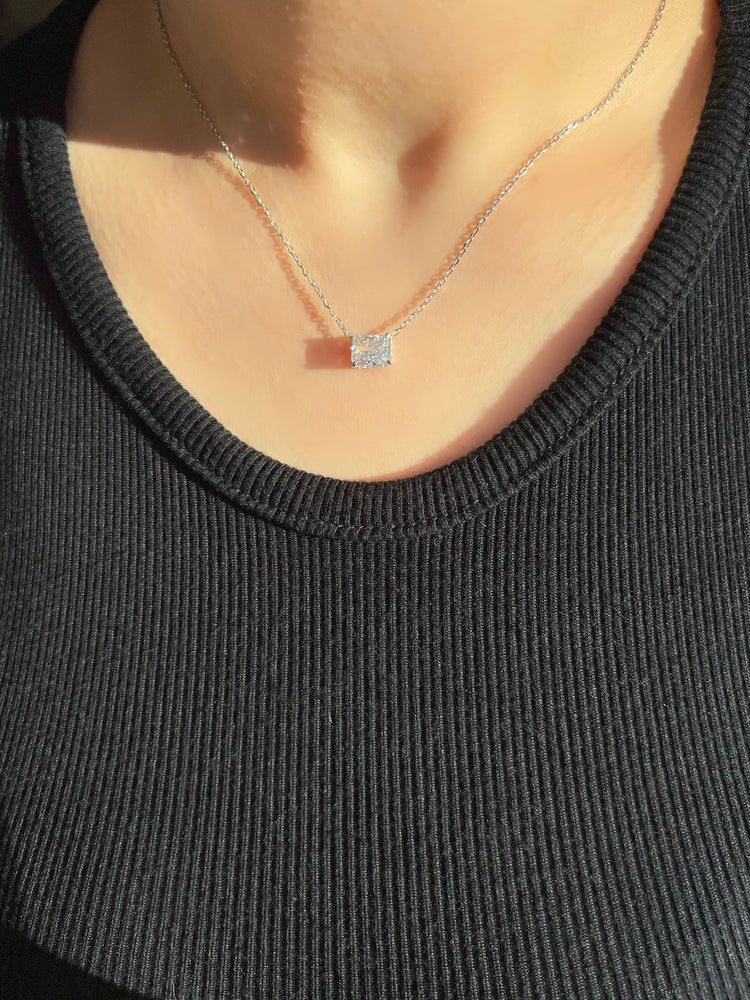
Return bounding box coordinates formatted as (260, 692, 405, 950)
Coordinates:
(154, 0, 666, 368)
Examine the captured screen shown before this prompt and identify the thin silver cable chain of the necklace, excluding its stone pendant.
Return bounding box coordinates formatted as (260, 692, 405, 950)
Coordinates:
(154, 0, 666, 339)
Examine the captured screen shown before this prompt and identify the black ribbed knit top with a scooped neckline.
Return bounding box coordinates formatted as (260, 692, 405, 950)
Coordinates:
(0, 0, 750, 1000)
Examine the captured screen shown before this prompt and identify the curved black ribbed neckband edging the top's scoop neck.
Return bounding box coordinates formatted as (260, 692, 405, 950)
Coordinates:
(17, 0, 750, 540)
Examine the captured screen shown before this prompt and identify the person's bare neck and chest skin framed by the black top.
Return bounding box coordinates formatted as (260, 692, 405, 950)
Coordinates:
(67, 0, 719, 480)
